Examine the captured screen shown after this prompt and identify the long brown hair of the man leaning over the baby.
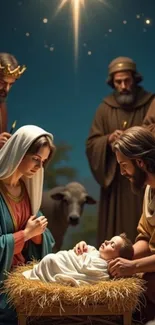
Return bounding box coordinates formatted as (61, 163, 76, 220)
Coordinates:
(113, 126, 155, 174)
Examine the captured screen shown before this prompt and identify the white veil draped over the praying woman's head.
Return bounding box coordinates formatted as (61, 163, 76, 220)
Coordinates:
(0, 125, 53, 215)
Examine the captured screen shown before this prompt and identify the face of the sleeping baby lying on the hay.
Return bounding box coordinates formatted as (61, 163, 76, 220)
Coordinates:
(99, 236, 123, 260)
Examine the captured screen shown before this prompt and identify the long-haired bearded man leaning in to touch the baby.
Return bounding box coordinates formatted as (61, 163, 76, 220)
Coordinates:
(109, 126, 155, 324)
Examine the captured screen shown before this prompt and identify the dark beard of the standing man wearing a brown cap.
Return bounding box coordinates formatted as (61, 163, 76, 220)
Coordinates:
(114, 87, 136, 107)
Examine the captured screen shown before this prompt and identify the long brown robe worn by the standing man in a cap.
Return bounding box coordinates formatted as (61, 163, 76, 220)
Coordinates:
(86, 87, 155, 245)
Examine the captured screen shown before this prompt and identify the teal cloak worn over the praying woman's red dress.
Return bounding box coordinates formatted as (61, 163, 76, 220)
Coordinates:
(0, 195, 55, 313)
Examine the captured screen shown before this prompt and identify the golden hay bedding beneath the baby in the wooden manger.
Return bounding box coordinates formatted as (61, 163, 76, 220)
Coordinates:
(4, 264, 144, 316)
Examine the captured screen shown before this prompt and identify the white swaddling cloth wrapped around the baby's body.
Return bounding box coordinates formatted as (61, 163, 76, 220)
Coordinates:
(23, 246, 109, 286)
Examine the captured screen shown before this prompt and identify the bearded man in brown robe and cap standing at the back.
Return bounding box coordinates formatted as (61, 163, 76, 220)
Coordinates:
(86, 57, 155, 245)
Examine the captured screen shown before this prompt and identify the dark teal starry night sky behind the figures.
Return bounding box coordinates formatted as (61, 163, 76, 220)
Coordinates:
(0, 0, 155, 182)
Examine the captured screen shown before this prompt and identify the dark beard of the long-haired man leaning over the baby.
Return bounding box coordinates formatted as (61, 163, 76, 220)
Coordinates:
(124, 162, 147, 194)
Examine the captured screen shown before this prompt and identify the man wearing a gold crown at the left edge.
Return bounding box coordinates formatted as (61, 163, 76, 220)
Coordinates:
(0, 53, 26, 148)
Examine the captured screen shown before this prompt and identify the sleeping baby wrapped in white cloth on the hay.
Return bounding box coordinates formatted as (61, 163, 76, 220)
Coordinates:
(23, 233, 133, 286)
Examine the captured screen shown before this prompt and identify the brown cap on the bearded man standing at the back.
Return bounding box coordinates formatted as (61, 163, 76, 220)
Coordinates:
(107, 56, 143, 87)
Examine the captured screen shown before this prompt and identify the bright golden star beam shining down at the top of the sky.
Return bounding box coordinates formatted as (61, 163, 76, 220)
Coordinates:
(57, 0, 85, 67)
